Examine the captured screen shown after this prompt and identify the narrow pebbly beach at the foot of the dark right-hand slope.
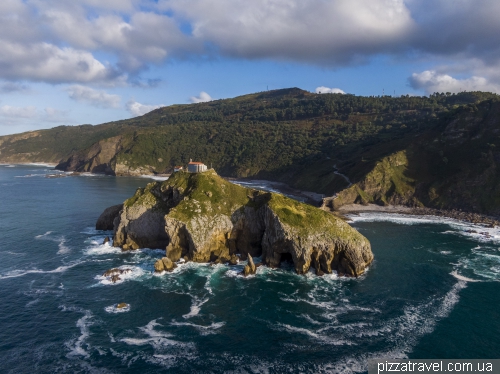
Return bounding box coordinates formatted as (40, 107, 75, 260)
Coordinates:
(335, 204, 500, 227)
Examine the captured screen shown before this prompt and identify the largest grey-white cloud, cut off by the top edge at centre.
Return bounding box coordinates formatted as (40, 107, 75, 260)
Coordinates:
(164, 0, 414, 65)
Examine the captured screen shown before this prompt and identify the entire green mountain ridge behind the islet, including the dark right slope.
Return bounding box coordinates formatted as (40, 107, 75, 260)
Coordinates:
(0, 88, 500, 215)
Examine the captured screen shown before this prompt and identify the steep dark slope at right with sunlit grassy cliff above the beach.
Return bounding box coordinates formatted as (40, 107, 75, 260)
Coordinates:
(325, 100, 500, 216)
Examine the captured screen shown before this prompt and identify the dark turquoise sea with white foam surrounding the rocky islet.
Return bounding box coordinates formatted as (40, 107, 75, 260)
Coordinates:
(0, 165, 500, 373)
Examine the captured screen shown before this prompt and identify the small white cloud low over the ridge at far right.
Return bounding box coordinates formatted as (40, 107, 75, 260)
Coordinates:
(410, 70, 500, 93)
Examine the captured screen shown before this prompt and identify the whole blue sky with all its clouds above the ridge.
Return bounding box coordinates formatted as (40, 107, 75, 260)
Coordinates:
(0, 0, 500, 135)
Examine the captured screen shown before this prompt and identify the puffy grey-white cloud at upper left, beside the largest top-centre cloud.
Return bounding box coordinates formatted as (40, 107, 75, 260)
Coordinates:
(45, 9, 199, 72)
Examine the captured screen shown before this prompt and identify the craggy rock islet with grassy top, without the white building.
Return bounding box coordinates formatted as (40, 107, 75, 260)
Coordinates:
(98, 170, 373, 277)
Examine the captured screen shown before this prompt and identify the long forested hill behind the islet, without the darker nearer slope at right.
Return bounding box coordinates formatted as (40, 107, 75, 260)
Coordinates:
(0, 88, 500, 213)
